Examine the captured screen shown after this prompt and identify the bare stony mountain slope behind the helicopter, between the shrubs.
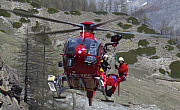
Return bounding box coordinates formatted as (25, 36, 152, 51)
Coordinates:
(0, 0, 180, 110)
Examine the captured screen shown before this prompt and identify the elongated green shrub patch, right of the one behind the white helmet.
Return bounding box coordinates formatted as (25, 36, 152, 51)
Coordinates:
(130, 47, 156, 56)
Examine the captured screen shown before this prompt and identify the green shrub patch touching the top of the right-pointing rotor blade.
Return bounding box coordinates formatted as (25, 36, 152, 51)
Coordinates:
(137, 24, 159, 34)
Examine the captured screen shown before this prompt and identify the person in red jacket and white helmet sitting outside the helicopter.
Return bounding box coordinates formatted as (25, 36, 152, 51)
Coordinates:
(106, 57, 128, 97)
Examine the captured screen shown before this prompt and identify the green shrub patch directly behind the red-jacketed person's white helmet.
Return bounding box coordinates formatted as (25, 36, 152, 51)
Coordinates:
(116, 52, 138, 64)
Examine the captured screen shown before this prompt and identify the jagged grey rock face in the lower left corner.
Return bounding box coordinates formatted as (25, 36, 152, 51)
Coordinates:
(0, 57, 22, 110)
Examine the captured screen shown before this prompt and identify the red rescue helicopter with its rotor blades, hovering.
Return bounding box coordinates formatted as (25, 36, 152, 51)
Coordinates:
(0, 9, 174, 106)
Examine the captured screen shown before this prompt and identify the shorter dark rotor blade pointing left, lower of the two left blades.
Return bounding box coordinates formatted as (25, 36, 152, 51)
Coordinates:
(31, 28, 82, 35)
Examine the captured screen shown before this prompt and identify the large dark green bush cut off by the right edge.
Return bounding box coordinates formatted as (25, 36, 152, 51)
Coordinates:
(169, 60, 180, 78)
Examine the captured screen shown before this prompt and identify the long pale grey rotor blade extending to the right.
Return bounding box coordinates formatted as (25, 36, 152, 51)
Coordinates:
(95, 28, 174, 37)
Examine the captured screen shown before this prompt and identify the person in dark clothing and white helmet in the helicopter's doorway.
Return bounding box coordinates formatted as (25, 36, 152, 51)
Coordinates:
(101, 55, 111, 74)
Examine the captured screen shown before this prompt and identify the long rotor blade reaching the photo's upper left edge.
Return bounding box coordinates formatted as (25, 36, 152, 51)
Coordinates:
(0, 9, 83, 27)
